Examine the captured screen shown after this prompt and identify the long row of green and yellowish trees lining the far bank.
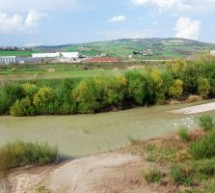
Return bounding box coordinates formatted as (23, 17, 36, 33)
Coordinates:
(0, 60, 215, 116)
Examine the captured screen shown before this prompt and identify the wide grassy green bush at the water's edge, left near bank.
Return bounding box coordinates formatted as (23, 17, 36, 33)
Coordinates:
(0, 141, 58, 172)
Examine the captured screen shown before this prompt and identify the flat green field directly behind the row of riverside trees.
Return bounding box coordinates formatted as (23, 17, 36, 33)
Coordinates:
(0, 64, 124, 81)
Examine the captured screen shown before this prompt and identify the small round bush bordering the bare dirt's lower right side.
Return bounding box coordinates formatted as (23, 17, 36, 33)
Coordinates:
(142, 169, 163, 183)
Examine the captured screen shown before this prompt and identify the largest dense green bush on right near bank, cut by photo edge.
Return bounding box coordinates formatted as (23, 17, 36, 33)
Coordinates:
(189, 133, 215, 159)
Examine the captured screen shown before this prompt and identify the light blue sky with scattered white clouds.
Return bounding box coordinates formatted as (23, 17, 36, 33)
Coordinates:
(0, 0, 215, 46)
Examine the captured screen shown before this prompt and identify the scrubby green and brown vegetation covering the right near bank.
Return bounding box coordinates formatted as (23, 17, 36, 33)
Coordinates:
(130, 116, 215, 193)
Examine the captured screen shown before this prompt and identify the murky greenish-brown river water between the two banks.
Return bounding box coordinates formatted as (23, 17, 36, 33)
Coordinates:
(0, 103, 215, 156)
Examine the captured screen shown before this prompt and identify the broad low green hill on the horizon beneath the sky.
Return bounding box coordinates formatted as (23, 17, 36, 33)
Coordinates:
(33, 38, 215, 59)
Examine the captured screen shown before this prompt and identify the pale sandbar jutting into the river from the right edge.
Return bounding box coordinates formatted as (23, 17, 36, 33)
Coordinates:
(171, 102, 215, 115)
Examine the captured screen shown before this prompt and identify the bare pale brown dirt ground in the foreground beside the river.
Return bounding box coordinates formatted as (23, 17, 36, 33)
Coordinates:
(10, 153, 154, 193)
